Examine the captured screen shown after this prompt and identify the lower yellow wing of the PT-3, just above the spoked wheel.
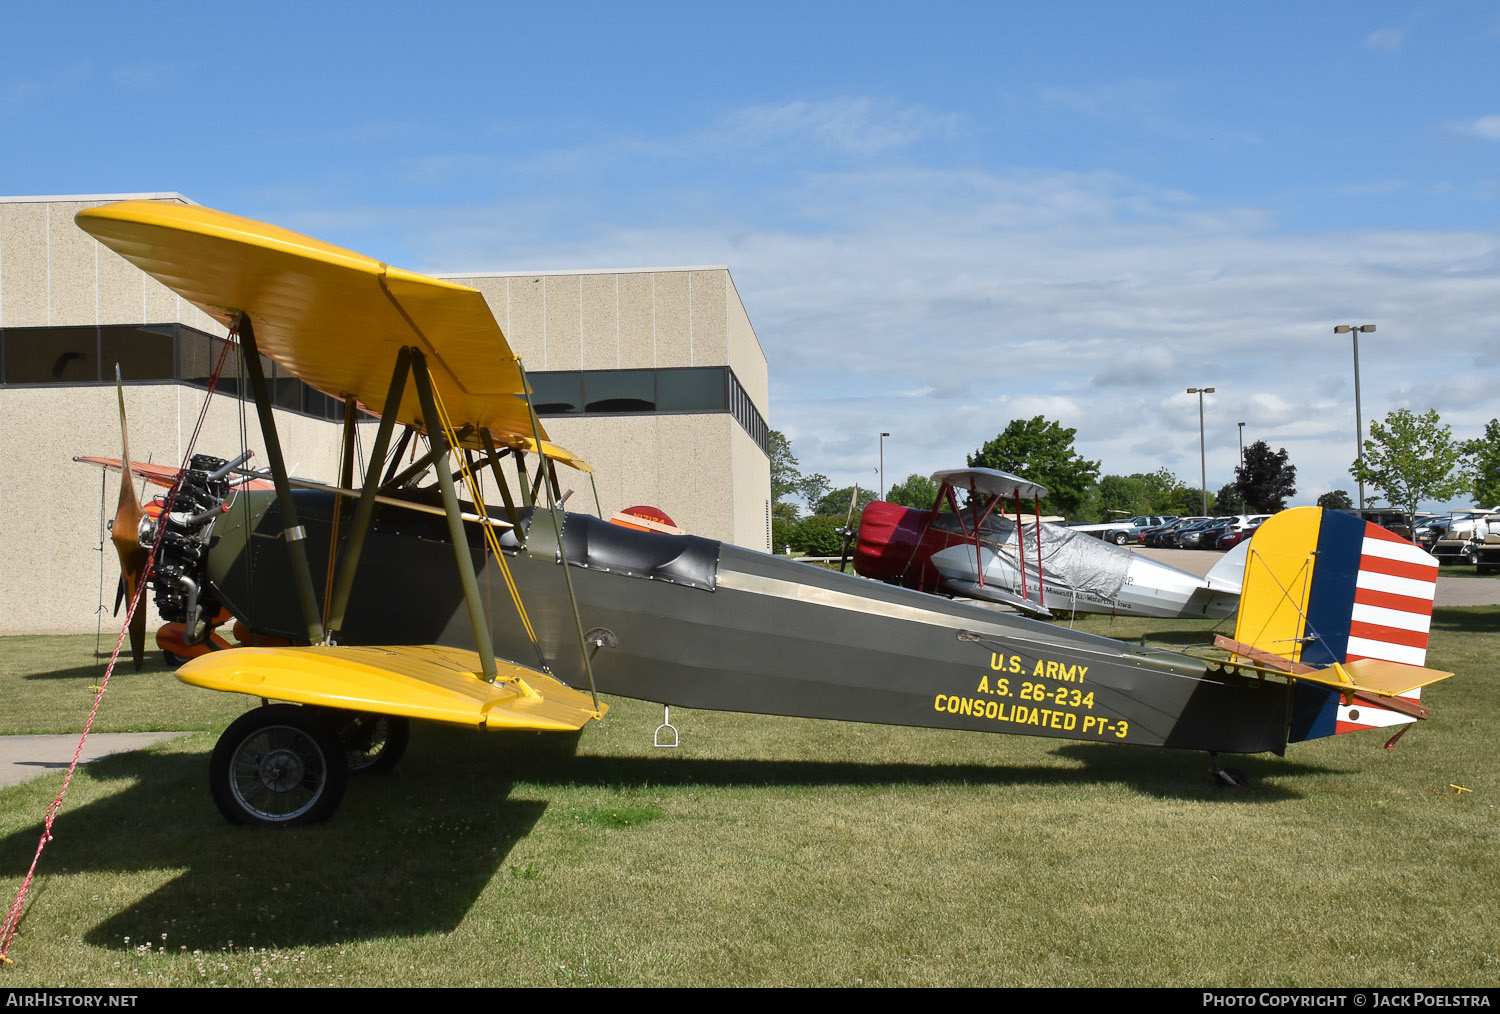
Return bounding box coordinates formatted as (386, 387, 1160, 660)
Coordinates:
(177, 645, 608, 732)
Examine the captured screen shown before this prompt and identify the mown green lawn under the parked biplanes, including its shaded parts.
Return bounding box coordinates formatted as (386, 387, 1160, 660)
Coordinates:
(0, 608, 1500, 987)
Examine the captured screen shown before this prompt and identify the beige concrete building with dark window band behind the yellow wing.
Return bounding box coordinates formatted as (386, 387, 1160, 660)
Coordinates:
(0, 194, 771, 635)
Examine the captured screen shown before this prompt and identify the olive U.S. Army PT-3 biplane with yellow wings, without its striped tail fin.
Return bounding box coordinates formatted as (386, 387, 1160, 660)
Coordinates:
(78, 201, 1446, 825)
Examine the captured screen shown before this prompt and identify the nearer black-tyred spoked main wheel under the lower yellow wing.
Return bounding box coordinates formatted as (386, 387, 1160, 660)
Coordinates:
(209, 704, 350, 828)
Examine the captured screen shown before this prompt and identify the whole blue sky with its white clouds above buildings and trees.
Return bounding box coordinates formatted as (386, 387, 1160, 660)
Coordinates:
(0, 3, 1500, 503)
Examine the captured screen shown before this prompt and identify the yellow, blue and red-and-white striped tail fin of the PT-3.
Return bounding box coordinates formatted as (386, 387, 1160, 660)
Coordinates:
(1235, 507, 1442, 741)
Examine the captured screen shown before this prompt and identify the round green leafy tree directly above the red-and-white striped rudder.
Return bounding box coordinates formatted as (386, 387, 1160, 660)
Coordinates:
(1349, 408, 1470, 531)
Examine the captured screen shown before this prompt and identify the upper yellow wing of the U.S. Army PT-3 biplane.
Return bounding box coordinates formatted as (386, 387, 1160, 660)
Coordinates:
(77, 201, 588, 470)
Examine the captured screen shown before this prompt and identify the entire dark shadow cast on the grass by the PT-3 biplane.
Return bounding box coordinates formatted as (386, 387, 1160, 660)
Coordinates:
(0, 726, 1326, 951)
